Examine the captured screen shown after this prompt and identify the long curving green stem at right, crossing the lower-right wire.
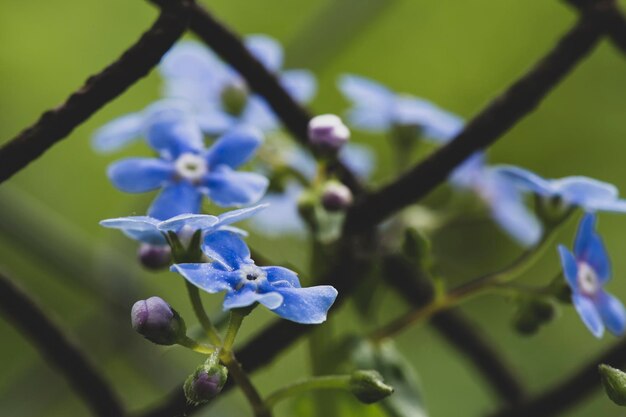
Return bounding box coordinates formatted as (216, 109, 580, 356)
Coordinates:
(370, 210, 572, 341)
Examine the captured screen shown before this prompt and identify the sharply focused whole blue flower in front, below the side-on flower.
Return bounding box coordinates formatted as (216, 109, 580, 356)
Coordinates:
(171, 231, 337, 324)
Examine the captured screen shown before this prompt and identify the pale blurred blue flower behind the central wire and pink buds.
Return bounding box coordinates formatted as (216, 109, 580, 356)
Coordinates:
(251, 143, 375, 236)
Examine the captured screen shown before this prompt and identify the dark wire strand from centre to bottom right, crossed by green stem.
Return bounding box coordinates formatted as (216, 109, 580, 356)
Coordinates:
(384, 255, 526, 405)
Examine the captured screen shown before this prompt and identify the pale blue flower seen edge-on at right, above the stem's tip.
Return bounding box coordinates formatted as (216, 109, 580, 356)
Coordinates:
(497, 165, 626, 213)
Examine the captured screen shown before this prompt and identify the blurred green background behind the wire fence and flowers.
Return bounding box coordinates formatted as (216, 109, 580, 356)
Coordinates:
(0, 0, 626, 417)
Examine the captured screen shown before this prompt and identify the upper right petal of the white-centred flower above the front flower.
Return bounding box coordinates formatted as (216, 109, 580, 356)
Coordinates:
(207, 128, 263, 168)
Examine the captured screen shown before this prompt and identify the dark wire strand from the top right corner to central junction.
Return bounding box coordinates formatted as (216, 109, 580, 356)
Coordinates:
(346, 0, 617, 230)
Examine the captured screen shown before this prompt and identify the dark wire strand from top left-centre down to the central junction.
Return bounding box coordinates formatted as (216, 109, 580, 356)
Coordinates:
(150, 0, 363, 194)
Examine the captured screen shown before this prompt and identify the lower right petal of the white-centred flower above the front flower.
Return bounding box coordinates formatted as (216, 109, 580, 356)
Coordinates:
(204, 165, 269, 207)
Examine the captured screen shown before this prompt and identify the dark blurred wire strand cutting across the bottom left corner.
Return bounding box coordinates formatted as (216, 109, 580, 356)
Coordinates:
(0, 274, 125, 417)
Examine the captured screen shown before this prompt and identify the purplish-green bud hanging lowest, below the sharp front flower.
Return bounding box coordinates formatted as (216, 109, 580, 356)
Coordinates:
(183, 355, 228, 405)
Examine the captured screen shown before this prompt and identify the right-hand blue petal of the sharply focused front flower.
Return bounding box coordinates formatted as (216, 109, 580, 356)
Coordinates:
(272, 285, 337, 324)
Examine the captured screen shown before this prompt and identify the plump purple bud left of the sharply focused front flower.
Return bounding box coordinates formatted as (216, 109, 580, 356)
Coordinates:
(130, 297, 186, 345)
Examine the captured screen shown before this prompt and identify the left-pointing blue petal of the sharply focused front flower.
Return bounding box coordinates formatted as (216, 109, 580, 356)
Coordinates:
(170, 262, 240, 294)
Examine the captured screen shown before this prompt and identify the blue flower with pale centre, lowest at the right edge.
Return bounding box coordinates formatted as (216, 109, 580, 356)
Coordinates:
(559, 214, 626, 338)
